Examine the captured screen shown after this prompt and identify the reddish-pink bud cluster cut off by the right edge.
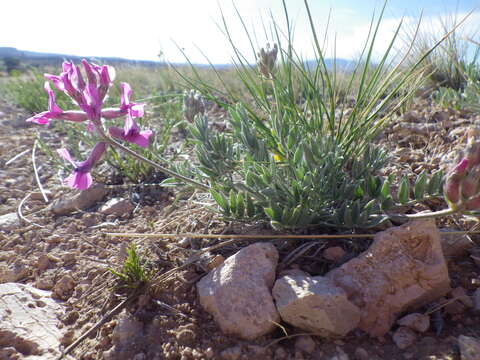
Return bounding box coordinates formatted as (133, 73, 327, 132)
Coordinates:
(444, 142, 480, 211)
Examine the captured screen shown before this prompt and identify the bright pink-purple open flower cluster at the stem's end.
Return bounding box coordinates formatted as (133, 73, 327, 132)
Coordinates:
(27, 60, 152, 190)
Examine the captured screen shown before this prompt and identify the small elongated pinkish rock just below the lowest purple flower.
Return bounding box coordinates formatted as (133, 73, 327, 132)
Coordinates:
(51, 184, 107, 215)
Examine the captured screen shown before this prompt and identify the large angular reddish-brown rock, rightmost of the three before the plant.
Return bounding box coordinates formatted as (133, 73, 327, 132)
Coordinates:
(326, 220, 450, 337)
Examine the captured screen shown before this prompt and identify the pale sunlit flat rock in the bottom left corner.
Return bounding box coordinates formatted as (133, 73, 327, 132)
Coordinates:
(0, 283, 62, 360)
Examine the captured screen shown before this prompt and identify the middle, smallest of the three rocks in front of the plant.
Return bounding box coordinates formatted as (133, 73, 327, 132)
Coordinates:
(272, 275, 360, 337)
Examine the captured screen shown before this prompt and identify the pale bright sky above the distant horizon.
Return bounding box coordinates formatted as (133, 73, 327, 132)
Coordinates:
(0, 0, 480, 64)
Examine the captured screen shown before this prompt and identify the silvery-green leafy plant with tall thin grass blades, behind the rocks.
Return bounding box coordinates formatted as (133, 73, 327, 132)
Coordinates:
(173, 2, 462, 228)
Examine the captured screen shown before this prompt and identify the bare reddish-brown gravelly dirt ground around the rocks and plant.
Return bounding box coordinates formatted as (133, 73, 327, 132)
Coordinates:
(0, 98, 480, 360)
